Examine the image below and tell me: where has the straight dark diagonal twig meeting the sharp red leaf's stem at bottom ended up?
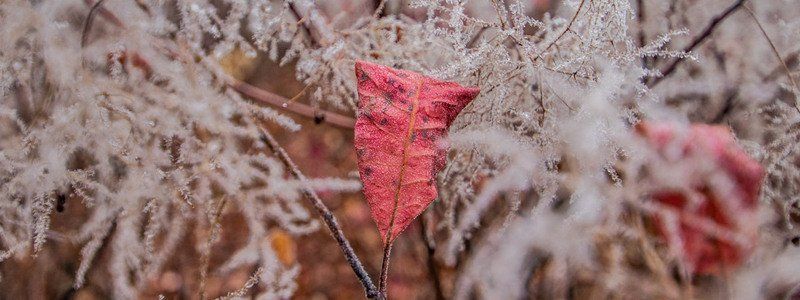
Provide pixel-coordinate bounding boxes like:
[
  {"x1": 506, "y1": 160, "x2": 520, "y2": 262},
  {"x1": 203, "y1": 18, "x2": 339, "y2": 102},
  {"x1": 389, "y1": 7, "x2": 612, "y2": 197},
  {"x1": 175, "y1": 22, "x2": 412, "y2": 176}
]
[{"x1": 261, "y1": 129, "x2": 380, "y2": 299}]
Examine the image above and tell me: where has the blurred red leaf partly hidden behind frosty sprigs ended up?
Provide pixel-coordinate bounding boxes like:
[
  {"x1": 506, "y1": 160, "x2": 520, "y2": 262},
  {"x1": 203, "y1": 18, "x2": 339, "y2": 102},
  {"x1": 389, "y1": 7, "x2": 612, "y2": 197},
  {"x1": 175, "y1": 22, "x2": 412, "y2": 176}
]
[{"x1": 637, "y1": 122, "x2": 764, "y2": 274}]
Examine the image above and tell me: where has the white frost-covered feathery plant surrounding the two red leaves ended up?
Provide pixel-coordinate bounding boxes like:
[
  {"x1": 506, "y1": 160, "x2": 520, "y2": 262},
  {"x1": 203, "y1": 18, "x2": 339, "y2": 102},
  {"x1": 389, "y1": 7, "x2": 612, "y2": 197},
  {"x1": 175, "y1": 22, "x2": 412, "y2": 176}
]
[{"x1": 0, "y1": 0, "x2": 800, "y2": 299}]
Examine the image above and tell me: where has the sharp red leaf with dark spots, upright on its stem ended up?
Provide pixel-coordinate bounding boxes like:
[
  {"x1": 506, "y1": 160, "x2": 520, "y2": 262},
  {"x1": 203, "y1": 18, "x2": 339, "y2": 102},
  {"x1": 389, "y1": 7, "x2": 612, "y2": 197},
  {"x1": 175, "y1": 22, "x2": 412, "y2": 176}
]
[{"x1": 355, "y1": 61, "x2": 480, "y2": 243}]
